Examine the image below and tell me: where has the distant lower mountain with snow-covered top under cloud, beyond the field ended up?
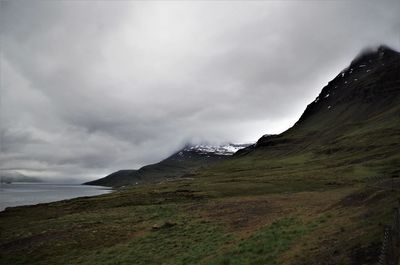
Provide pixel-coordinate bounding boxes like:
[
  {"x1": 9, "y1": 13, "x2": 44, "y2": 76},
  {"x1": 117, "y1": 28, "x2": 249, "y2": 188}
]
[{"x1": 84, "y1": 144, "x2": 249, "y2": 187}]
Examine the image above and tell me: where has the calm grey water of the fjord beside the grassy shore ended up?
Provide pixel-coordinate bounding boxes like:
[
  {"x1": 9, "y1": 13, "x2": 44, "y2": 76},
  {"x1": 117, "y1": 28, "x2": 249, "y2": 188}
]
[{"x1": 0, "y1": 183, "x2": 111, "y2": 211}]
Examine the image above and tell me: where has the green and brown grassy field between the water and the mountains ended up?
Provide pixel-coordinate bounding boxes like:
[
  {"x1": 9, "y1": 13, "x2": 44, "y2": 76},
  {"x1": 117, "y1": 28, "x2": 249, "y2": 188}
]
[{"x1": 0, "y1": 156, "x2": 400, "y2": 265}]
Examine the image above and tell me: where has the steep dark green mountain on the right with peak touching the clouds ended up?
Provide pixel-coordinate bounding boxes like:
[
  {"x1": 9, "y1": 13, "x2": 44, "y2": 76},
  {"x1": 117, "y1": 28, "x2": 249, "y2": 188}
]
[{"x1": 217, "y1": 46, "x2": 400, "y2": 184}]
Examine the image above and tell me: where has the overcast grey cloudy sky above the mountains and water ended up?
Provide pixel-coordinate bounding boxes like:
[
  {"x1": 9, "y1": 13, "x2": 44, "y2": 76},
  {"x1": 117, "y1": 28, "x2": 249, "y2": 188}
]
[{"x1": 0, "y1": 0, "x2": 400, "y2": 181}]
